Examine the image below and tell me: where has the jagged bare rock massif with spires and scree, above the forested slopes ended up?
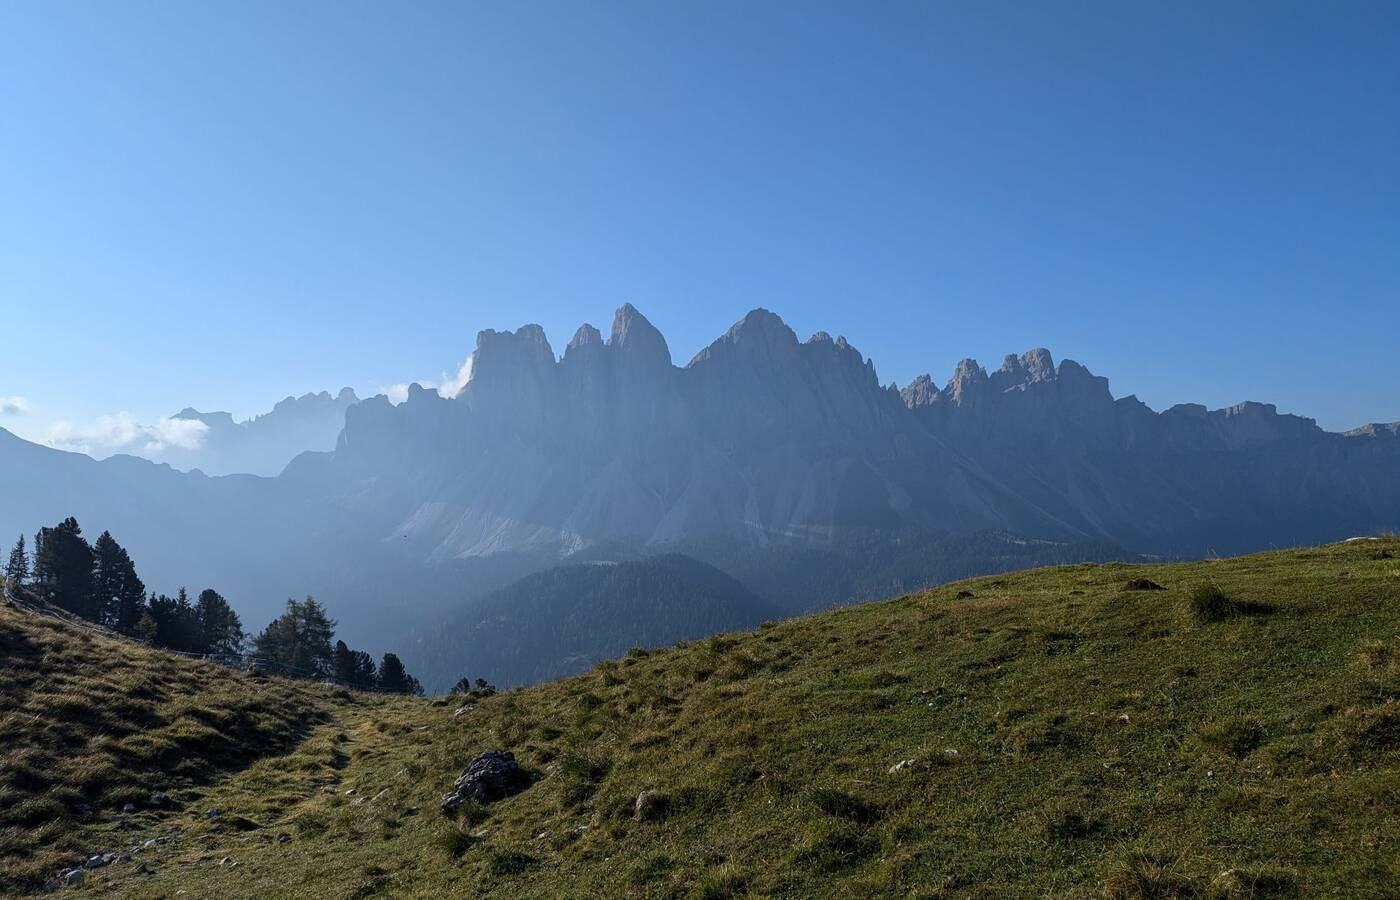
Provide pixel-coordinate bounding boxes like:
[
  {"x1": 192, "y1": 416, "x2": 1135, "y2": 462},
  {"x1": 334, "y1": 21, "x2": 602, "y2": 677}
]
[{"x1": 317, "y1": 305, "x2": 1400, "y2": 560}]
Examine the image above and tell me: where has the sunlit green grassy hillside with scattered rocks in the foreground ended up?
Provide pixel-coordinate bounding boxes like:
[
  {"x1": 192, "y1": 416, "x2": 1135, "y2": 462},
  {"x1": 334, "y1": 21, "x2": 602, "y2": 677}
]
[{"x1": 0, "y1": 540, "x2": 1400, "y2": 899}]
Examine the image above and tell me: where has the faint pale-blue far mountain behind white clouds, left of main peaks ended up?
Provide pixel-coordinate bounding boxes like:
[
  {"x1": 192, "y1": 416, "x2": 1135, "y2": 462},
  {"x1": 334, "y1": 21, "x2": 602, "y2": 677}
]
[{"x1": 141, "y1": 388, "x2": 360, "y2": 476}]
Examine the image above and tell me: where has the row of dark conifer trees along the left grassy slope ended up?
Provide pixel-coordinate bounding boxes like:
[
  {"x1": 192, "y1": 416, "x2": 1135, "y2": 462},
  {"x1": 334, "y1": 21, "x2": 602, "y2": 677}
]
[{"x1": 4, "y1": 516, "x2": 423, "y2": 694}]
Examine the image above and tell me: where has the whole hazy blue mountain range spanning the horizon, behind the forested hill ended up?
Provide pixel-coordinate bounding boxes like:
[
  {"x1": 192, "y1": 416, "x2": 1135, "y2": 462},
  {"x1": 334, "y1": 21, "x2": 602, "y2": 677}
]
[{"x1": 0, "y1": 305, "x2": 1400, "y2": 676}]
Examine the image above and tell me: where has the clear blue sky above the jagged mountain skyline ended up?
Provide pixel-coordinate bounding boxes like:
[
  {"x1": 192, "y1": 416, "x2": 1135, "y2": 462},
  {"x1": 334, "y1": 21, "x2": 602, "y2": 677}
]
[{"x1": 0, "y1": 0, "x2": 1400, "y2": 450}]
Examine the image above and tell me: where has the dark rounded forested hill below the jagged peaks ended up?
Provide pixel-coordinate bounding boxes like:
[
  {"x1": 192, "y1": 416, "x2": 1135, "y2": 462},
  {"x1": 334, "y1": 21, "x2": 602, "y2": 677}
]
[{"x1": 403, "y1": 553, "x2": 778, "y2": 690}]
